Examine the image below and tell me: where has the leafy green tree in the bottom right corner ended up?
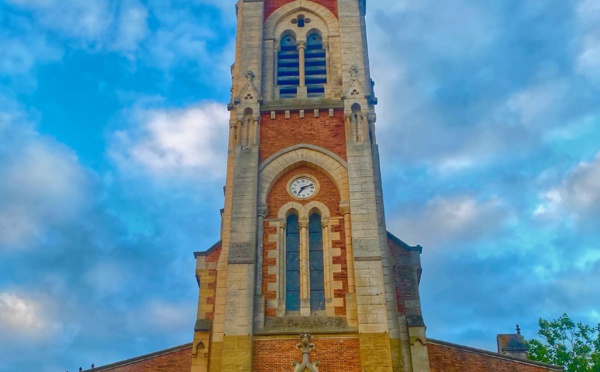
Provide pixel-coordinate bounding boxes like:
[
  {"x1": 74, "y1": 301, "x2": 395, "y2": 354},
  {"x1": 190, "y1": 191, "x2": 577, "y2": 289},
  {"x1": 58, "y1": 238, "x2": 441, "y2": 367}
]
[{"x1": 525, "y1": 314, "x2": 600, "y2": 372}]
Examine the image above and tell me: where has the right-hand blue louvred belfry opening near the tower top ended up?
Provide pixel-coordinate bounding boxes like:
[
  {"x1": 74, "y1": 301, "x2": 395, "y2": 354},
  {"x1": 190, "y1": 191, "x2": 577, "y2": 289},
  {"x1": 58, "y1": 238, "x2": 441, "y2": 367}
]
[{"x1": 304, "y1": 33, "x2": 327, "y2": 97}]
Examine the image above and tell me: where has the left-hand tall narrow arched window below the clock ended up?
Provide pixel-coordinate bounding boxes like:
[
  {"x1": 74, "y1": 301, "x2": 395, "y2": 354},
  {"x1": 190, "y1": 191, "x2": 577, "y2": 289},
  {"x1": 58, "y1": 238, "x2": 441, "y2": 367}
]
[{"x1": 285, "y1": 214, "x2": 300, "y2": 311}]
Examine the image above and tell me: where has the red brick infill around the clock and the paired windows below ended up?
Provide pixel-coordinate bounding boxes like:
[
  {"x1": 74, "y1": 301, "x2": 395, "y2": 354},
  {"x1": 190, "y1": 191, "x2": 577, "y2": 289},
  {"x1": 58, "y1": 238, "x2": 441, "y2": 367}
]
[{"x1": 263, "y1": 166, "x2": 348, "y2": 317}]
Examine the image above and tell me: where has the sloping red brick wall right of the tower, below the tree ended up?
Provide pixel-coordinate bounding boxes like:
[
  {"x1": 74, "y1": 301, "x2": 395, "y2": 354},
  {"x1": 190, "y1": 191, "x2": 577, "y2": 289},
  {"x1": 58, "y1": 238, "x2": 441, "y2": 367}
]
[{"x1": 427, "y1": 342, "x2": 549, "y2": 372}]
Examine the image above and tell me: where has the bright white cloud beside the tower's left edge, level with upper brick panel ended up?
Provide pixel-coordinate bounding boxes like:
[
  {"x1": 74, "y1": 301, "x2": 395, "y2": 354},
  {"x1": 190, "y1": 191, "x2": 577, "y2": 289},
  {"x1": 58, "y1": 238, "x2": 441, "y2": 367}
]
[{"x1": 111, "y1": 103, "x2": 229, "y2": 178}]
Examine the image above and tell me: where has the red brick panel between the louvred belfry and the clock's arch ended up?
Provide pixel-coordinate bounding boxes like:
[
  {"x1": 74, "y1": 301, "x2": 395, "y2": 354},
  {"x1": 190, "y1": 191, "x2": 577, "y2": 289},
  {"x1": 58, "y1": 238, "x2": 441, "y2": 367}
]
[{"x1": 260, "y1": 110, "x2": 346, "y2": 162}]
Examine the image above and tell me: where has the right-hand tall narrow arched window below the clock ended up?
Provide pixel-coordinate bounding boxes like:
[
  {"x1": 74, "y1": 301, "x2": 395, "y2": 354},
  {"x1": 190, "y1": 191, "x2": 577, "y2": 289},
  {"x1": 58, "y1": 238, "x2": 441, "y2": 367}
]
[{"x1": 308, "y1": 214, "x2": 325, "y2": 310}]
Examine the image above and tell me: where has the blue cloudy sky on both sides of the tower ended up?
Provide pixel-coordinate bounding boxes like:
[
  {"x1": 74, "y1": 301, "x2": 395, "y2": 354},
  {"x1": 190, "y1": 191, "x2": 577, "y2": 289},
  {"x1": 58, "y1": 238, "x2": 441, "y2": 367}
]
[{"x1": 0, "y1": 0, "x2": 600, "y2": 372}]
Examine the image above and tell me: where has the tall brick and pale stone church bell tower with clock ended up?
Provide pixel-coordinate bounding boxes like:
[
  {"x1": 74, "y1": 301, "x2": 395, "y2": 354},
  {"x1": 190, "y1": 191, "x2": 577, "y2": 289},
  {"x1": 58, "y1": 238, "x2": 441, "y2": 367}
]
[{"x1": 192, "y1": 0, "x2": 429, "y2": 372}]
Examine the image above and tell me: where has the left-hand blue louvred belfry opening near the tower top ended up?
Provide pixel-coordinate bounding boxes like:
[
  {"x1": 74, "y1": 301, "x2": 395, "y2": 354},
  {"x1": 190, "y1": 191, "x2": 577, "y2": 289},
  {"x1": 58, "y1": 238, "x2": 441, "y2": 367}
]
[{"x1": 277, "y1": 35, "x2": 300, "y2": 98}]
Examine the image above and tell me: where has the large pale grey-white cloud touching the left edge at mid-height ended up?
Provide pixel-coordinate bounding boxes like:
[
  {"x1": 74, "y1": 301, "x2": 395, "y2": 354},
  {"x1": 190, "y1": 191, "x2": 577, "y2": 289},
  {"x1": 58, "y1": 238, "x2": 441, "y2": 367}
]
[{"x1": 0, "y1": 104, "x2": 89, "y2": 250}]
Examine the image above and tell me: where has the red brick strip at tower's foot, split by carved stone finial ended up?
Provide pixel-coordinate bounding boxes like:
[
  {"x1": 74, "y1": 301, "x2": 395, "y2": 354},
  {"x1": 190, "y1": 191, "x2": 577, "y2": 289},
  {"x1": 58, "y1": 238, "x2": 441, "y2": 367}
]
[{"x1": 252, "y1": 338, "x2": 360, "y2": 372}]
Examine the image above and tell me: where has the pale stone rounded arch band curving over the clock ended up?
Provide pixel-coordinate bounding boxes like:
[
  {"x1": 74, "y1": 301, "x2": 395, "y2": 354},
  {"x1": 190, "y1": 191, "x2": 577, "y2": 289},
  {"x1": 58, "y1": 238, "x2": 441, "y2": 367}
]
[{"x1": 258, "y1": 145, "x2": 349, "y2": 204}]
